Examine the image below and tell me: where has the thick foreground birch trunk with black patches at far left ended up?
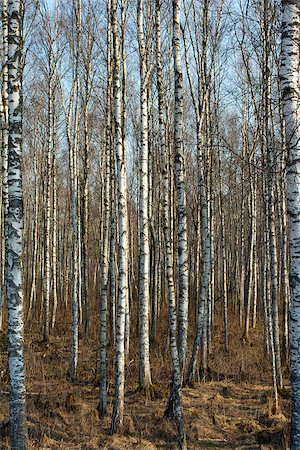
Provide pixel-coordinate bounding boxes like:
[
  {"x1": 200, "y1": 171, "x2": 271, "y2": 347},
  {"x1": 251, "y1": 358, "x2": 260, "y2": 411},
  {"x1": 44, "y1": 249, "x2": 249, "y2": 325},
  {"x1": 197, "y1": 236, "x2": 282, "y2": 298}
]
[{"x1": 7, "y1": 0, "x2": 28, "y2": 450}]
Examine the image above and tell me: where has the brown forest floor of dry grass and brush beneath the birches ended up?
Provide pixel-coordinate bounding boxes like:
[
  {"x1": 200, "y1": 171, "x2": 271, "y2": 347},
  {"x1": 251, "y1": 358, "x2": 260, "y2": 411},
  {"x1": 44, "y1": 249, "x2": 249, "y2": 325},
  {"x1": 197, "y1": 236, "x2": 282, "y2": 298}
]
[{"x1": 0, "y1": 318, "x2": 290, "y2": 450}]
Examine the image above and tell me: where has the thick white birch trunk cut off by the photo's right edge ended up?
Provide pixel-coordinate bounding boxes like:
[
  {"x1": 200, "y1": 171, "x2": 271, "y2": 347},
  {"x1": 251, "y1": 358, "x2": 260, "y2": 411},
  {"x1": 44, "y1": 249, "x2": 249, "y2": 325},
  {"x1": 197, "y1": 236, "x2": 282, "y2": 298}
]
[{"x1": 280, "y1": 0, "x2": 300, "y2": 450}]
